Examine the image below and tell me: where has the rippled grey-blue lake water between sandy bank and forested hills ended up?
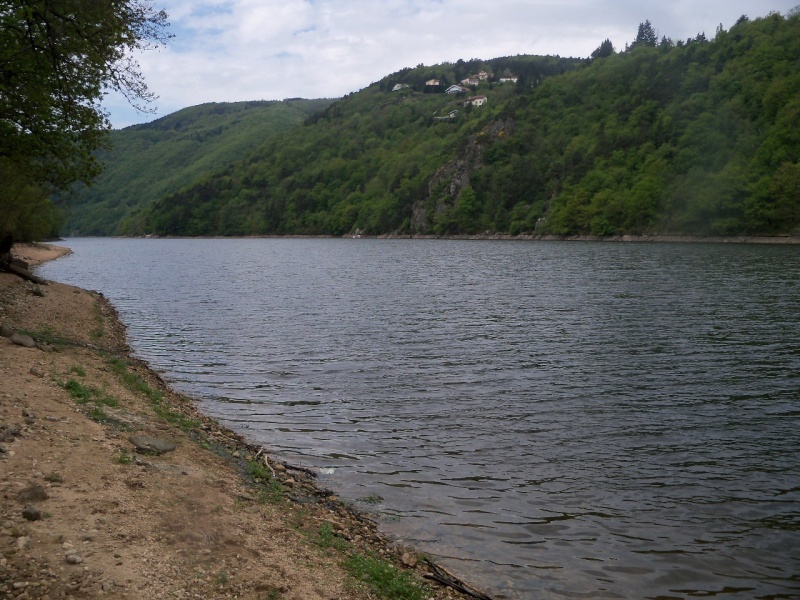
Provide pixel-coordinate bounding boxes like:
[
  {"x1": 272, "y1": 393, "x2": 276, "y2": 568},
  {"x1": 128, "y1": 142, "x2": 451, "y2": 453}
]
[{"x1": 38, "y1": 239, "x2": 800, "y2": 599}]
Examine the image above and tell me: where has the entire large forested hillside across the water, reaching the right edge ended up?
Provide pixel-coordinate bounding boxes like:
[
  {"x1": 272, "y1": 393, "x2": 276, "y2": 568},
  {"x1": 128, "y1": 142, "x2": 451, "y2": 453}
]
[{"x1": 109, "y1": 14, "x2": 800, "y2": 235}]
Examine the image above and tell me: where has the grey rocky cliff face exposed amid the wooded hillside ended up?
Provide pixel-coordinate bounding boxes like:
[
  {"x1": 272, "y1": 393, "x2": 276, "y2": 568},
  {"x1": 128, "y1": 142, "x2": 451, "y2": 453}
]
[{"x1": 411, "y1": 119, "x2": 514, "y2": 231}]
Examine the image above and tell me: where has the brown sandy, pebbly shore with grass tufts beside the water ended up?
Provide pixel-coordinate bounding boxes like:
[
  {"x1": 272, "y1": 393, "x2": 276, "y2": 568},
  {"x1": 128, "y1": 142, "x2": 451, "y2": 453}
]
[{"x1": 0, "y1": 245, "x2": 482, "y2": 600}]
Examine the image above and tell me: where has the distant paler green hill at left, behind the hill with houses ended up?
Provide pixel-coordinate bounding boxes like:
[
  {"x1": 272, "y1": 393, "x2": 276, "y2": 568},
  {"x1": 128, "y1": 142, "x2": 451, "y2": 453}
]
[{"x1": 58, "y1": 99, "x2": 331, "y2": 235}]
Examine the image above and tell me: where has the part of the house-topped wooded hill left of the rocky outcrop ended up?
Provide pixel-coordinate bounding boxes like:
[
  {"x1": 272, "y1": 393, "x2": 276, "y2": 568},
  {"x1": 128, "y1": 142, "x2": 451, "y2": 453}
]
[{"x1": 122, "y1": 56, "x2": 582, "y2": 235}]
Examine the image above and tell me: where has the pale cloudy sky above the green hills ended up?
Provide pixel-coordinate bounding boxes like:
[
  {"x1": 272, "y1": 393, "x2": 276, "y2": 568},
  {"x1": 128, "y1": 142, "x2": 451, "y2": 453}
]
[{"x1": 105, "y1": 0, "x2": 800, "y2": 128}]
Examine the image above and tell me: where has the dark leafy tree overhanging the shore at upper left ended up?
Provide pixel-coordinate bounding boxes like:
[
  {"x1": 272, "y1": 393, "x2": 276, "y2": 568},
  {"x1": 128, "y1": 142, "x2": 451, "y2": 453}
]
[{"x1": 0, "y1": 0, "x2": 168, "y2": 244}]
